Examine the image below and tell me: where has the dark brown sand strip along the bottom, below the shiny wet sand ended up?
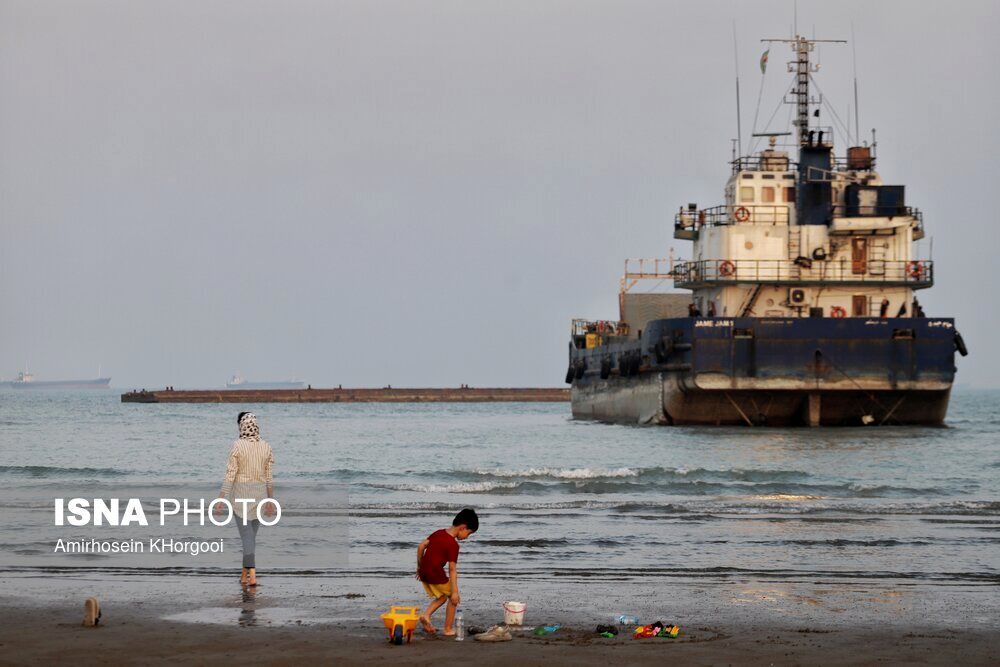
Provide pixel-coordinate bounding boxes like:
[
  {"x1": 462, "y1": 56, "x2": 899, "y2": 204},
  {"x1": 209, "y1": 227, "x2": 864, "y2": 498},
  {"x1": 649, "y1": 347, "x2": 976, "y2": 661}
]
[{"x1": 0, "y1": 600, "x2": 1000, "y2": 665}]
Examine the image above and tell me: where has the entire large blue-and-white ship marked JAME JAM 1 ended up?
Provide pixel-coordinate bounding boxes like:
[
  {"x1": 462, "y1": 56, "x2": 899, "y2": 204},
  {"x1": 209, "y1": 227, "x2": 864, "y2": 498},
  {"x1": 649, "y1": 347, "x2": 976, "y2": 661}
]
[{"x1": 566, "y1": 36, "x2": 968, "y2": 426}]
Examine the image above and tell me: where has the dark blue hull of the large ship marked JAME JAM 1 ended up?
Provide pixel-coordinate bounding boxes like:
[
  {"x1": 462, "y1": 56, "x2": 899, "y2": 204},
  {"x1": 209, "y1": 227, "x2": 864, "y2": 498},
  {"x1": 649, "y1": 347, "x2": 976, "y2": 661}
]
[{"x1": 567, "y1": 318, "x2": 957, "y2": 425}]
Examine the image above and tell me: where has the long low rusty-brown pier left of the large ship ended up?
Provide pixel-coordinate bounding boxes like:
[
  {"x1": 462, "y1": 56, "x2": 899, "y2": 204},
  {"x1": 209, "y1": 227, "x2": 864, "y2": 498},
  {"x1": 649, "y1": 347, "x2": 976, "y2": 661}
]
[{"x1": 122, "y1": 387, "x2": 569, "y2": 403}]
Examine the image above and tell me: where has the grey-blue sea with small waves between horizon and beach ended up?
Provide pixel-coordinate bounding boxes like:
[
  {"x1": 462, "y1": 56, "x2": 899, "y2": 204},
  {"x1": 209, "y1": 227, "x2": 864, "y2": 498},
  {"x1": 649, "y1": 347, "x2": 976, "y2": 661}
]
[{"x1": 0, "y1": 390, "x2": 1000, "y2": 623}]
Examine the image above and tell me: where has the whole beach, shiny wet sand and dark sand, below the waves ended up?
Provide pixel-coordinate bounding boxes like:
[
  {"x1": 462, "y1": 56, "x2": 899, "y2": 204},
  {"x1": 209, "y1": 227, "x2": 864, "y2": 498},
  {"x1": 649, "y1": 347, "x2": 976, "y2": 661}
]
[{"x1": 0, "y1": 575, "x2": 1000, "y2": 665}]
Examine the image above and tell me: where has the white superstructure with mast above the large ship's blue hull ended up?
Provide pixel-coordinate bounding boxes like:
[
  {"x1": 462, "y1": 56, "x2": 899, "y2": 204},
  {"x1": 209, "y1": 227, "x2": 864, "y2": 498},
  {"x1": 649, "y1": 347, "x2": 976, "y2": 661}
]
[{"x1": 673, "y1": 37, "x2": 933, "y2": 317}]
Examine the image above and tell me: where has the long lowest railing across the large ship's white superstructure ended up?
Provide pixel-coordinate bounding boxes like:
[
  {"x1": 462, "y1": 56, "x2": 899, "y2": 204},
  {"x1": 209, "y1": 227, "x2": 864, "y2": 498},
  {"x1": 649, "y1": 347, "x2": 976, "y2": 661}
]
[{"x1": 674, "y1": 258, "x2": 934, "y2": 288}]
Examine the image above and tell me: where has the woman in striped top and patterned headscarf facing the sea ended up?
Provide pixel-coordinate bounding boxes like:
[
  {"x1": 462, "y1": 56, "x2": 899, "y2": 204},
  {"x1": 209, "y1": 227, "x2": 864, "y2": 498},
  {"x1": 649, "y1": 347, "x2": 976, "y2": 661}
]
[{"x1": 215, "y1": 412, "x2": 274, "y2": 586}]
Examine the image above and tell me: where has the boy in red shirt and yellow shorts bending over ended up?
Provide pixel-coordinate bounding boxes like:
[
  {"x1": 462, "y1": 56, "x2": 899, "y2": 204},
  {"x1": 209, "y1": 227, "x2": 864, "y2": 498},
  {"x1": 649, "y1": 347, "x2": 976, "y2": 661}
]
[{"x1": 417, "y1": 508, "x2": 479, "y2": 637}]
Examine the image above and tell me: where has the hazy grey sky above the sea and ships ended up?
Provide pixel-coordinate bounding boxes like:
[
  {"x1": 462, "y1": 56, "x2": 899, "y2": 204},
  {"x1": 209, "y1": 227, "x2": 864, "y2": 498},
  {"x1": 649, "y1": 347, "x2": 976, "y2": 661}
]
[{"x1": 0, "y1": 0, "x2": 1000, "y2": 389}]
